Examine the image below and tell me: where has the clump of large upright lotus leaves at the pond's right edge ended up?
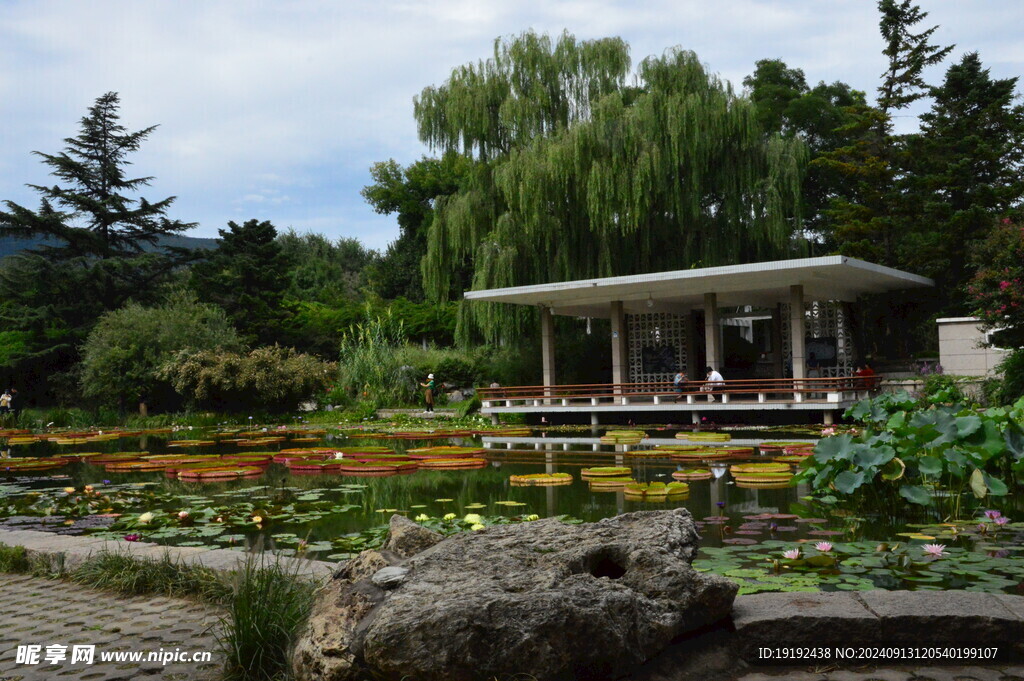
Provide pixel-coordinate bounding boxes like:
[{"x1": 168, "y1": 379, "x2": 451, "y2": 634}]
[{"x1": 800, "y1": 389, "x2": 1024, "y2": 518}]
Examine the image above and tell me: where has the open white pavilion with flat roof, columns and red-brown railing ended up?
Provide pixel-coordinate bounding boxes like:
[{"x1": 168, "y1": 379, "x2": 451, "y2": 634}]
[{"x1": 465, "y1": 255, "x2": 934, "y2": 423}]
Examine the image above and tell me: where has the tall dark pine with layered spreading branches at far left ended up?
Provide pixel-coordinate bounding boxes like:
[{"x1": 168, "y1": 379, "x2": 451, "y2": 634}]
[{"x1": 0, "y1": 92, "x2": 194, "y2": 391}]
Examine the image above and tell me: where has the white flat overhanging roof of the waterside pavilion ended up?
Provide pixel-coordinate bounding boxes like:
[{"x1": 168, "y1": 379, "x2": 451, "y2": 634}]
[{"x1": 464, "y1": 255, "x2": 934, "y2": 317}]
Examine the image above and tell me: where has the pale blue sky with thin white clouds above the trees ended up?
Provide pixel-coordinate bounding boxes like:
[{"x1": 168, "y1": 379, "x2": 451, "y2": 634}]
[{"x1": 0, "y1": 0, "x2": 1024, "y2": 249}]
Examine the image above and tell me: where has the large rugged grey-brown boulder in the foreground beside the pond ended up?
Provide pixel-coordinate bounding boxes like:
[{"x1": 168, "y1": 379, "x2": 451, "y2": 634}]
[{"x1": 293, "y1": 509, "x2": 736, "y2": 681}]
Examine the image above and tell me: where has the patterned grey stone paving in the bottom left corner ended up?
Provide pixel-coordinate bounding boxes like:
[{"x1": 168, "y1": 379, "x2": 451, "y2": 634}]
[{"x1": 0, "y1": 573, "x2": 223, "y2": 681}]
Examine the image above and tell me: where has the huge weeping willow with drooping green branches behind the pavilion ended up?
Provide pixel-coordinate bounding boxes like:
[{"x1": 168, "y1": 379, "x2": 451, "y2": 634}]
[{"x1": 415, "y1": 33, "x2": 806, "y2": 339}]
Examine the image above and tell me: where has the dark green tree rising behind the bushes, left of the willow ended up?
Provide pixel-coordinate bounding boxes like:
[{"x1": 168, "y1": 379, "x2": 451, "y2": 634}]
[{"x1": 190, "y1": 220, "x2": 292, "y2": 344}]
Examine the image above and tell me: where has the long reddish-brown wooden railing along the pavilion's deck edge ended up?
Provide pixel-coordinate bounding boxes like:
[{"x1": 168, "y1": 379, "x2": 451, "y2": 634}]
[{"x1": 476, "y1": 377, "x2": 877, "y2": 409}]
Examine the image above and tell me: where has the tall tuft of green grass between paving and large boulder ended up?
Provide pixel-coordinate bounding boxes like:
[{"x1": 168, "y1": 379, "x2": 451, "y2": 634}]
[{"x1": 218, "y1": 553, "x2": 316, "y2": 681}]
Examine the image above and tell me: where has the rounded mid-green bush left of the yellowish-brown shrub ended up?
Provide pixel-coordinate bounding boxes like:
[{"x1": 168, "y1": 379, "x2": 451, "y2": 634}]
[{"x1": 81, "y1": 293, "x2": 242, "y2": 410}]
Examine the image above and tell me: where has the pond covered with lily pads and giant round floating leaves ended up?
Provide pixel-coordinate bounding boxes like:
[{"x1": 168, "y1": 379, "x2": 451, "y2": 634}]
[{"x1": 0, "y1": 427, "x2": 1024, "y2": 593}]
